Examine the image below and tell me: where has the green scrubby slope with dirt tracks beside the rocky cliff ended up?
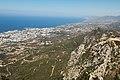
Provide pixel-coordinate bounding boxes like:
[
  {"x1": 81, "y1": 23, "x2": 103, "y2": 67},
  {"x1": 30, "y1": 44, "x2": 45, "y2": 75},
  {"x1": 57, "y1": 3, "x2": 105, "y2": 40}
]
[{"x1": 1, "y1": 32, "x2": 84, "y2": 80}]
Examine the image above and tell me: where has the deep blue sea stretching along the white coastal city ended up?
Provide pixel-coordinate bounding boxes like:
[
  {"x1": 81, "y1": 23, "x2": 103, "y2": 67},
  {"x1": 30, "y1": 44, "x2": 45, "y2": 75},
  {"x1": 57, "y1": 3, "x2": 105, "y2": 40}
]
[{"x1": 0, "y1": 16, "x2": 85, "y2": 32}]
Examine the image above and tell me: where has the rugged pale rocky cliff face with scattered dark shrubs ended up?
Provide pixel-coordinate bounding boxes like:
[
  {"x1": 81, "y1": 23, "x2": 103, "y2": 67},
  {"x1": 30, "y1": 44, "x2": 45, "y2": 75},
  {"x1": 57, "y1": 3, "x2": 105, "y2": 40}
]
[{"x1": 63, "y1": 30, "x2": 120, "y2": 80}]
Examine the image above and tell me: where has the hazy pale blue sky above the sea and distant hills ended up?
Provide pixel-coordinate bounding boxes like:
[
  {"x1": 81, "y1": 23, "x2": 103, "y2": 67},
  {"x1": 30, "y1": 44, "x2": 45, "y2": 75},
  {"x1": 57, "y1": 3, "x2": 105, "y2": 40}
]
[{"x1": 0, "y1": 0, "x2": 120, "y2": 17}]
